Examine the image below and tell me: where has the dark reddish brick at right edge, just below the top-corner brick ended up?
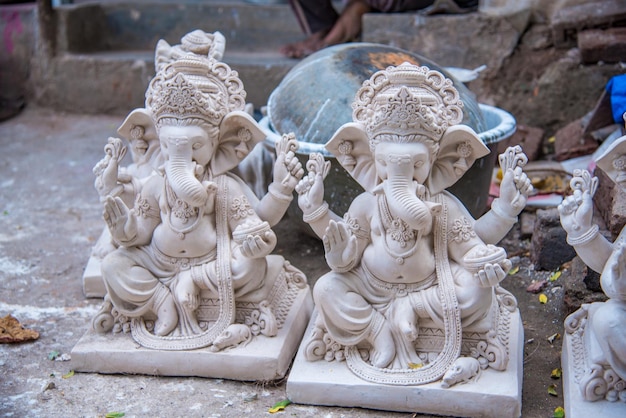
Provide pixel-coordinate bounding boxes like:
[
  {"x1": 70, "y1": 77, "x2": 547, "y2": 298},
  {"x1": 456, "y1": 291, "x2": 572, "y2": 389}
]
[{"x1": 578, "y1": 27, "x2": 626, "y2": 64}]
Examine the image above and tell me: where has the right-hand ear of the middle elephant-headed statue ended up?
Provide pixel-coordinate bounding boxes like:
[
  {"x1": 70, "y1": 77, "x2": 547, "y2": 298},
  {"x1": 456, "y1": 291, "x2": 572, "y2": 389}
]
[{"x1": 427, "y1": 125, "x2": 490, "y2": 195}]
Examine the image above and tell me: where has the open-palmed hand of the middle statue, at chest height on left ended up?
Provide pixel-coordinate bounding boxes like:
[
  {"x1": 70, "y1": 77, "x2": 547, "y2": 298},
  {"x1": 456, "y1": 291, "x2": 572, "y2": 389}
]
[{"x1": 322, "y1": 220, "x2": 357, "y2": 272}]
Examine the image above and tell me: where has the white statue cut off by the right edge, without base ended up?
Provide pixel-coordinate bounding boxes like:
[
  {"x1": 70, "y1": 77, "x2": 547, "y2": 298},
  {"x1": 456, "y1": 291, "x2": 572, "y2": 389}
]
[{"x1": 559, "y1": 128, "x2": 626, "y2": 404}]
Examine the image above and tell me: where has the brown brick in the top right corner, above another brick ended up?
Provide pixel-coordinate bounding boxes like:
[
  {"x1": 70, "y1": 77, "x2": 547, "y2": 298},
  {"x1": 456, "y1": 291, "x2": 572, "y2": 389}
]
[{"x1": 551, "y1": 0, "x2": 626, "y2": 48}]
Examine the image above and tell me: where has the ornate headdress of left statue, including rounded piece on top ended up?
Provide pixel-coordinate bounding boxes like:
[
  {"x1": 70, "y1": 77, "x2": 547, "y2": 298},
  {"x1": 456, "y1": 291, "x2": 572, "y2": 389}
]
[{"x1": 146, "y1": 31, "x2": 246, "y2": 126}]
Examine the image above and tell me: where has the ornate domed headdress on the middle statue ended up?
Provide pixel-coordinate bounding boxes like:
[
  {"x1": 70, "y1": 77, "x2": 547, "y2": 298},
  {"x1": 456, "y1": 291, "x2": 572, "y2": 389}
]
[{"x1": 352, "y1": 62, "x2": 463, "y2": 147}]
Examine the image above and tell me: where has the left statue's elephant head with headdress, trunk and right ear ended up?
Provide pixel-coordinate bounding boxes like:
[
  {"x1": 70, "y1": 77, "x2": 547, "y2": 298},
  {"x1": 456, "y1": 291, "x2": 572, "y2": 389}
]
[{"x1": 146, "y1": 31, "x2": 265, "y2": 207}]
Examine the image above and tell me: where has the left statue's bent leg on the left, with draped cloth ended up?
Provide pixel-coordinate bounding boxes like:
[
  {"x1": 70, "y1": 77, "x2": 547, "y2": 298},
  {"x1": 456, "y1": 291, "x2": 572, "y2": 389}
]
[{"x1": 102, "y1": 250, "x2": 178, "y2": 335}]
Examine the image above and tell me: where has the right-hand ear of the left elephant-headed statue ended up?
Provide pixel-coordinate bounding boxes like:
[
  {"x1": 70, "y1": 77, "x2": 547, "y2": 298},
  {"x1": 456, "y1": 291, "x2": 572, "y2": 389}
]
[{"x1": 211, "y1": 110, "x2": 266, "y2": 176}]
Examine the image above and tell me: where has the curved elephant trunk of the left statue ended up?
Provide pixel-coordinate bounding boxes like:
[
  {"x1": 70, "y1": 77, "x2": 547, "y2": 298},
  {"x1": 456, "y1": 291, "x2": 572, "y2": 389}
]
[{"x1": 165, "y1": 138, "x2": 208, "y2": 207}]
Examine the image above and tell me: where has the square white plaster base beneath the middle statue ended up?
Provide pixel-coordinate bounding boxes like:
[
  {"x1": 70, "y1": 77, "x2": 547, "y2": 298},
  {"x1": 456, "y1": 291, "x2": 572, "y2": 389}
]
[{"x1": 287, "y1": 312, "x2": 524, "y2": 418}]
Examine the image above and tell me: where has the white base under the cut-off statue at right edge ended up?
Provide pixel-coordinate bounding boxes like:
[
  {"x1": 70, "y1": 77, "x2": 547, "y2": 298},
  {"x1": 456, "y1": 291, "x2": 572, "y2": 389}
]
[{"x1": 561, "y1": 332, "x2": 626, "y2": 418}]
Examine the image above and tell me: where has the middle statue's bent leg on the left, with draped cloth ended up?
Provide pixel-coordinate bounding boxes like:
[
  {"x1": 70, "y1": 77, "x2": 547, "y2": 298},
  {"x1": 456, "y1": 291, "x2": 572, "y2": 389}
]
[{"x1": 313, "y1": 272, "x2": 396, "y2": 367}]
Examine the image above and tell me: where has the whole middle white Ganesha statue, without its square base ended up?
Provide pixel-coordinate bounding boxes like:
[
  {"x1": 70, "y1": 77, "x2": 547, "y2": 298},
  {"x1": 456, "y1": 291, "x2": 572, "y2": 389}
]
[{"x1": 296, "y1": 63, "x2": 532, "y2": 387}]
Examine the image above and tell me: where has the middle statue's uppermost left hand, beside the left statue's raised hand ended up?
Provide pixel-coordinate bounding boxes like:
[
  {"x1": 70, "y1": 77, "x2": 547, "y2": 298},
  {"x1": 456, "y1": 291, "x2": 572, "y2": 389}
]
[{"x1": 296, "y1": 153, "x2": 330, "y2": 215}]
